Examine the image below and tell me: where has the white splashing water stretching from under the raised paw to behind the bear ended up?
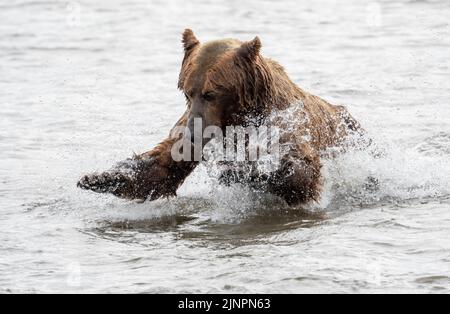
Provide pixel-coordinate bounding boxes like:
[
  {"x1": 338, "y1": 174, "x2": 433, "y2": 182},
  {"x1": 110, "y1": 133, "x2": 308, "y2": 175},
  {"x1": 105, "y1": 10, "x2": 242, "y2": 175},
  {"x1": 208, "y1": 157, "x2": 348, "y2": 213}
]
[{"x1": 91, "y1": 112, "x2": 450, "y2": 223}]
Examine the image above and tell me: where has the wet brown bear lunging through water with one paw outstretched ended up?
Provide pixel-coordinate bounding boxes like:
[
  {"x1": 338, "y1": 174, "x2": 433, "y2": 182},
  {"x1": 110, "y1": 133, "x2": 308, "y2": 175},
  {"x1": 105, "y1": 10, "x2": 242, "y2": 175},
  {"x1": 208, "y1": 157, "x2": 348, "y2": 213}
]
[{"x1": 78, "y1": 29, "x2": 361, "y2": 205}]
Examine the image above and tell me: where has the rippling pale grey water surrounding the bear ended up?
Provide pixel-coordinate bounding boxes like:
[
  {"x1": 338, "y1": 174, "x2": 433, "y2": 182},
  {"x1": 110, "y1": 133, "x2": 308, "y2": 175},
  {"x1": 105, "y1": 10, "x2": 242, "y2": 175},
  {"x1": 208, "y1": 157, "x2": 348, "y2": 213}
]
[{"x1": 0, "y1": 0, "x2": 450, "y2": 293}]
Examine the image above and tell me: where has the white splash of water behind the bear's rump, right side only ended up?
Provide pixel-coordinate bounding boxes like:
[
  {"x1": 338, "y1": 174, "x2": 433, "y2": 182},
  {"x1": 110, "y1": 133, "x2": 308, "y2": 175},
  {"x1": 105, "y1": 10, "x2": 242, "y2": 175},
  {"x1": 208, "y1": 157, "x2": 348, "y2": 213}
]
[{"x1": 322, "y1": 131, "x2": 450, "y2": 211}]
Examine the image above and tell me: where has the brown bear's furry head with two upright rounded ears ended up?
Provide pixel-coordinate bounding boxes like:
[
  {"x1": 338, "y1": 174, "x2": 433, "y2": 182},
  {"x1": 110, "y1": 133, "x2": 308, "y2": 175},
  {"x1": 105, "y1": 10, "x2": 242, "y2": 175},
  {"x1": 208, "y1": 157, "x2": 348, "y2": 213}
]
[{"x1": 178, "y1": 29, "x2": 283, "y2": 142}]
